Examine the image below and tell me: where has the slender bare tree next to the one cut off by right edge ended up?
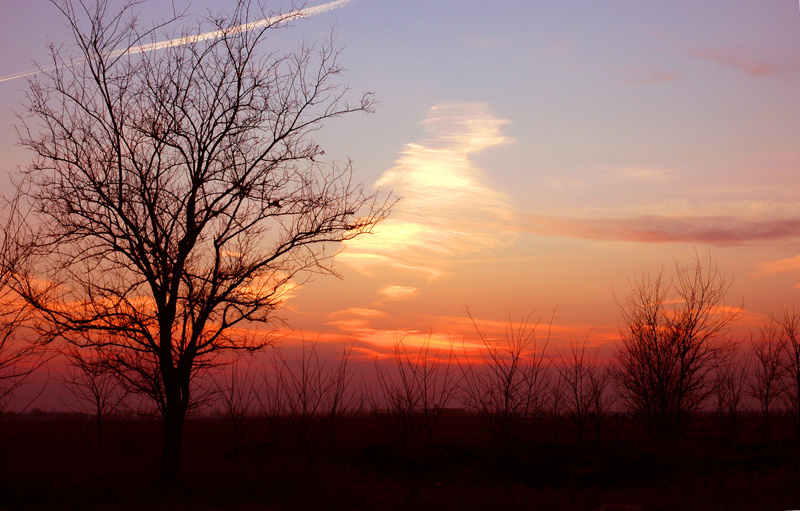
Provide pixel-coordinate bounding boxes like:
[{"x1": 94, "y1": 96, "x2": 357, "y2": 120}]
[{"x1": 748, "y1": 326, "x2": 785, "y2": 443}]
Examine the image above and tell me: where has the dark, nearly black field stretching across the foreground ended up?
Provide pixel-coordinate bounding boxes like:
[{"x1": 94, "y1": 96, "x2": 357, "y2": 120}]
[{"x1": 0, "y1": 416, "x2": 800, "y2": 510}]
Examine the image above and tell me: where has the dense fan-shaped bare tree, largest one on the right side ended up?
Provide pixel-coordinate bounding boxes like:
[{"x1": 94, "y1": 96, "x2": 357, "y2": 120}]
[{"x1": 613, "y1": 256, "x2": 741, "y2": 437}]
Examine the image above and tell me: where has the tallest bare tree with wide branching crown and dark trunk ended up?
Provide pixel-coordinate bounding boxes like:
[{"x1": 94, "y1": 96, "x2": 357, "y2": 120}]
[{"x1": 11, "y1": 0, "x2": 389, "y2": 484}]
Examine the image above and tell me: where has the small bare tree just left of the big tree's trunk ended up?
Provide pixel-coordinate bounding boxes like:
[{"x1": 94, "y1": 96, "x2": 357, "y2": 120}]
[{"x1": 61, "y1": 345, "x2": 127, "y2": 449}]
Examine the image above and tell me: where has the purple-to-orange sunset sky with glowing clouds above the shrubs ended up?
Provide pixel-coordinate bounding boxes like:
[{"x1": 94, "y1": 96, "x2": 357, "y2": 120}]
[{"x1": 0, "y1": 0, "x2": 800, "y2": 376}]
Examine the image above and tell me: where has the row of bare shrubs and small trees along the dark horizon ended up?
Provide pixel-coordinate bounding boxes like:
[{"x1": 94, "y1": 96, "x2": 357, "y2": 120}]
[{"x1": 29, "y1": 294, "x2": 800, "y2": 458}]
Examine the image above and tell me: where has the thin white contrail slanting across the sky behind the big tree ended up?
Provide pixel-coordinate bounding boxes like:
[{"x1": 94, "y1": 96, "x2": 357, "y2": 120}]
[{"x1": 0, "y1": 0, "x2": 356, "y2": 83}]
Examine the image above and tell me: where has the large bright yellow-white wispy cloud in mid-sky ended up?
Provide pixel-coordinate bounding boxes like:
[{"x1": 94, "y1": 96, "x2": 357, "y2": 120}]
[{"x1": 339, "y1": 103, "x2": 516, "y2": 277}]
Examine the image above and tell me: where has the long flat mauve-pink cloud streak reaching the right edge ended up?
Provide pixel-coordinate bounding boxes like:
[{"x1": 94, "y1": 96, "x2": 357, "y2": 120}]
[{"x1": 525, "y1": 215, "x2": 800, "y2": 245}]
